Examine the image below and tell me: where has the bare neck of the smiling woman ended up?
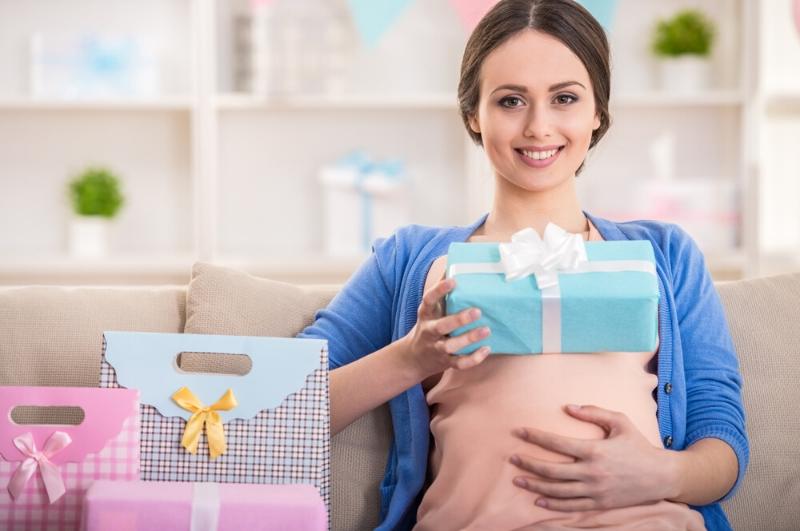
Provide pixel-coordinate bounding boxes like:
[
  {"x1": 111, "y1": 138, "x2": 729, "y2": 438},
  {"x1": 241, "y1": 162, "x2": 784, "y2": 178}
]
[{"x1": 482, "y1": 172, "x2": 589, "y2": 235}]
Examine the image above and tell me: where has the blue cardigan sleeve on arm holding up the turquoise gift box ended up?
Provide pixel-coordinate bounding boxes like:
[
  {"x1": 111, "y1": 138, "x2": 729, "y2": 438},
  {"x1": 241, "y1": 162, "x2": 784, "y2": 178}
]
[{"x1": 297, "y1": 235, "x2": 397, "y2": 370}]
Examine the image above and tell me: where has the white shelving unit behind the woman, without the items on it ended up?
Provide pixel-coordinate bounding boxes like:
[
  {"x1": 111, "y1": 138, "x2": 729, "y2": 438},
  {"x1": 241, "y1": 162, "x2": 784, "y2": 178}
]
[{"x1": 0, "y1": 0, "x2": 800, "y2": 284}]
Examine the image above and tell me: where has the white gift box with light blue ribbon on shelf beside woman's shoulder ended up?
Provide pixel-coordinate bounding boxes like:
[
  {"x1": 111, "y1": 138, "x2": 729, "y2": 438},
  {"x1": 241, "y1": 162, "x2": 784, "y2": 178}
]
[{"x1": 319, "y1": 151, "x2": 410, "y2": 257}]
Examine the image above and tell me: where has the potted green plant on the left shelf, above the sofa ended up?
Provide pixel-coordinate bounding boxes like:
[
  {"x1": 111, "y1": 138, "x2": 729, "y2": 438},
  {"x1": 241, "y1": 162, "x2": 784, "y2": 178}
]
[{"x1": 68, "y1": 167, "x2": 125, "y2": 258}]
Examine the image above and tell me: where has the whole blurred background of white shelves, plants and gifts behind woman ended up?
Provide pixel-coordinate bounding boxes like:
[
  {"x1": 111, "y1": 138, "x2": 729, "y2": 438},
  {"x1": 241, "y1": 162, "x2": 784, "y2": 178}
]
[{"x1": 0, "y1": 0, "x2": 800, "y2": 284}]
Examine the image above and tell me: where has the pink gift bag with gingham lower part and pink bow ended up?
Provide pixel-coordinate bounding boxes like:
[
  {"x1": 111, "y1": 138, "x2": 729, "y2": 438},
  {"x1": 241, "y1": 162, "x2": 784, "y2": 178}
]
[{"x1": 0, "y1": 387, "x2": 139, "y2": 531}]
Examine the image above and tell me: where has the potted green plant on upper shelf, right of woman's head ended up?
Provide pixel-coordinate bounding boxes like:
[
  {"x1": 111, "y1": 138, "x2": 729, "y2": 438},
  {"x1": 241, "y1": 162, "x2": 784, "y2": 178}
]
[{"x1": 651, "y1": 9, "x2": 716, "y2": 93}]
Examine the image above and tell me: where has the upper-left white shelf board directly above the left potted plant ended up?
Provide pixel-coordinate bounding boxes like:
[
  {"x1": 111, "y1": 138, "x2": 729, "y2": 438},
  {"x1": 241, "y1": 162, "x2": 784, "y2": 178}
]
[{"x1": 0, "y1": 97, "x2": 192, "y2": 111}]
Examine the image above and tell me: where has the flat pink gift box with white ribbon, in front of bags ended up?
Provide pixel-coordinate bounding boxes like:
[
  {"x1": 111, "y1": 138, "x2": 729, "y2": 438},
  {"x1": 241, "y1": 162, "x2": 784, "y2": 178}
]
[{"x1": 83, "y1": 481, "x2": 328, "y2": 531}]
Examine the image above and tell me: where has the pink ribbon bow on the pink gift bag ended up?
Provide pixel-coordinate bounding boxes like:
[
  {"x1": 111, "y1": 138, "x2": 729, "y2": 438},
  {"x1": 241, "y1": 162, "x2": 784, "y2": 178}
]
[{"x1": 8, "y1": 431, "x2": 72, "y2": 503}]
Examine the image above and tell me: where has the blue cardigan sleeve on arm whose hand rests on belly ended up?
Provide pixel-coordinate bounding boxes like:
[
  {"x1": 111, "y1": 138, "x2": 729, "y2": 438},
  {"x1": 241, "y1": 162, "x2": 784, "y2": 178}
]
[{"x1": 671, "y1": 227, "x2": 749, "y2": 500}]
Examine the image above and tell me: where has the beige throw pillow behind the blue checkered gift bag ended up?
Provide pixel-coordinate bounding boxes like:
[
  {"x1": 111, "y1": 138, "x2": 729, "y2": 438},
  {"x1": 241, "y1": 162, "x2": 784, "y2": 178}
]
[{"x1": 181, "y1": 263, "x2": 392, "y2": 530}]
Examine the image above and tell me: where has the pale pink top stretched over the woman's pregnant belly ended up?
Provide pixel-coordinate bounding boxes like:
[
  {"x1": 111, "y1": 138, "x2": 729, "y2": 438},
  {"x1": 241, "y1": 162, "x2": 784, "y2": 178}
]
[{"x1": 415, "y1": 223, "x2": 705, "y2": 531}]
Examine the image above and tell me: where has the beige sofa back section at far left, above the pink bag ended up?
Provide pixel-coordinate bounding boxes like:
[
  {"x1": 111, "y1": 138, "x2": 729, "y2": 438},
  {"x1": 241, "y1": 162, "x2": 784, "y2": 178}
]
[{"x1": 0, "y1": 286, "x2": 186, "y2": 387}]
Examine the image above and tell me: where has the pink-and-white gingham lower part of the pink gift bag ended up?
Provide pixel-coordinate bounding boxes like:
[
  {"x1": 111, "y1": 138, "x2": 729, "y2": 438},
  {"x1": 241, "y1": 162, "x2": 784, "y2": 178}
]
[{"x1": 0, "y1": 415, "x2": 139, "y2": 531}]
